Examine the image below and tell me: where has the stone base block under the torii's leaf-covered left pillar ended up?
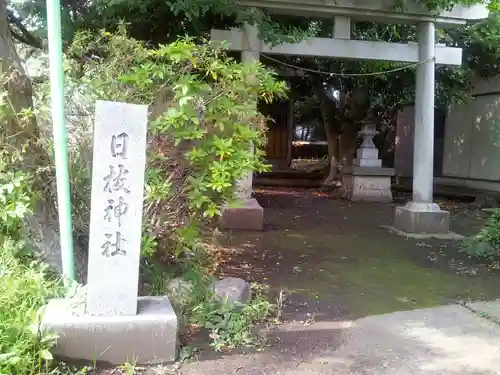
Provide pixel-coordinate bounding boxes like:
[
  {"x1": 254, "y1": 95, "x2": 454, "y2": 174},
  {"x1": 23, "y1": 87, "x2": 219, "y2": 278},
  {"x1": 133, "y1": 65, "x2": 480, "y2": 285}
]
[{"x1": 220, "y1": 198, "x2": 264, "y2": 230}]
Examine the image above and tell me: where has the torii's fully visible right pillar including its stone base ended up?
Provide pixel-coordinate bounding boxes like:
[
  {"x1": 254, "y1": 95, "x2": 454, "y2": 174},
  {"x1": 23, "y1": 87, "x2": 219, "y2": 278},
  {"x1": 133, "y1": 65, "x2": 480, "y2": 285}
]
[{"x1": 395, "y1": 22, "x2": 450, "y2": 234}]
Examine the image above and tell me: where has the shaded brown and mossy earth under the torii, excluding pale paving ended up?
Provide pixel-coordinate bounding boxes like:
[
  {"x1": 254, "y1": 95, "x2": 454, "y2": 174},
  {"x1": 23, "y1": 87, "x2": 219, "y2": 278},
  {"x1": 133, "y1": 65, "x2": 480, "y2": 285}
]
[{"x1": 216, "y1": 189, "x2": 500, "y2": 321}]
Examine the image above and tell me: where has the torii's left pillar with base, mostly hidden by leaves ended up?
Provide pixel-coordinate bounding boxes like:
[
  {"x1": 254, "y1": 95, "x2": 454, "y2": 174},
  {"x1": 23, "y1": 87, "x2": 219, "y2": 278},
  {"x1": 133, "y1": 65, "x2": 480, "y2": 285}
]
[{"x1": 221, "y1": 24, "x2": 264, "y2": 230}]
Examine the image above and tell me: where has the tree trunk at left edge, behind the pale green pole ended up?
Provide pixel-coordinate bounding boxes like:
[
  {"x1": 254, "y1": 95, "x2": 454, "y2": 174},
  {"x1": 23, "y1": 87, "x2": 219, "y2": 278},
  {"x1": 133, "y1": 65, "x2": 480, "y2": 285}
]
[{"x1": 0, "y1": 0, "x2": 86, "y2": 281}]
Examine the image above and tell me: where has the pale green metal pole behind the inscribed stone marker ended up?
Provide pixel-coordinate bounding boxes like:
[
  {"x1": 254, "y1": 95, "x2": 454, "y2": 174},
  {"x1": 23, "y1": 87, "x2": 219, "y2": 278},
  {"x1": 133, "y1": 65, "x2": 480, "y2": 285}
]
[{"x1": 47, "y1": 0, "x2": 75, "y2": 281}]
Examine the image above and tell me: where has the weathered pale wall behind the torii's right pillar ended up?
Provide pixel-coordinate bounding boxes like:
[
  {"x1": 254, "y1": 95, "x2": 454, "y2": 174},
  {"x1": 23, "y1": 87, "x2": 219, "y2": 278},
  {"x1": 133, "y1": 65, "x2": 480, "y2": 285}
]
[{"x1": 394, "y1": 76, "x2": 500, "y2": 191}]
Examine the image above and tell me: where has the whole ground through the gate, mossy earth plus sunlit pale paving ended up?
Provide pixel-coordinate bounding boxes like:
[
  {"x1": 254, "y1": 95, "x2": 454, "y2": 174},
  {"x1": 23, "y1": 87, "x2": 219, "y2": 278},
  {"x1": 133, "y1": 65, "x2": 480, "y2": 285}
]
[{"x1": 174, "y1": 189, "x2": 500, "y2": 375}]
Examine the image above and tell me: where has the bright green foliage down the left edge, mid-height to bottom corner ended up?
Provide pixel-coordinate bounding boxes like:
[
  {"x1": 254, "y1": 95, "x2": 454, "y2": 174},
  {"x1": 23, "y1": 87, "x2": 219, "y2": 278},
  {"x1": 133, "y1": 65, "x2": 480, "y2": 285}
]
[{"x1": 0, "y1": 78, "x2": 60, "y2": 375}]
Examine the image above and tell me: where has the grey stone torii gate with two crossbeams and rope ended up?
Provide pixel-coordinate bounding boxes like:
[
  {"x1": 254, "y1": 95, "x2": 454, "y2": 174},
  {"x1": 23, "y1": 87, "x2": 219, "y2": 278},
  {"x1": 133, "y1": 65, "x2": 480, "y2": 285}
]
[{"x1": 216, "y1": 0, "x2": 488, "y2": 234}]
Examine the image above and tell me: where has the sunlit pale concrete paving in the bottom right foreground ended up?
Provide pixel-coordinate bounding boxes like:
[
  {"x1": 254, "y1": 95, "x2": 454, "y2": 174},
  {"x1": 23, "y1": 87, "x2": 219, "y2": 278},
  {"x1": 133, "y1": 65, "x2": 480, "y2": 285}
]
[{"x1": 181, "y1": 305, "x2": 500, "y2": 375}]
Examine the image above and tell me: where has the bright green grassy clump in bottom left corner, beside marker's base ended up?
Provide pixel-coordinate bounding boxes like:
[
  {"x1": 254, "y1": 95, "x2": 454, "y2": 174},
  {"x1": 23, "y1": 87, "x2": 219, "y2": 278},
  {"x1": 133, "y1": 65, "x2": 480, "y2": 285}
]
[{"x1": 0, "y1": 240, "x2": 60, "y2": 375}]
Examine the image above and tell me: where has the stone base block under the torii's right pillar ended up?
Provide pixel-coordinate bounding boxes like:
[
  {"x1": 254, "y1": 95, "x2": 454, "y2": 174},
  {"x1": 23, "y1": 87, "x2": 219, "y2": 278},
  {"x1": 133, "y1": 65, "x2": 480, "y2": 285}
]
[{"x1": 394, "y1": 202, "x2": 450, "y2": 234}]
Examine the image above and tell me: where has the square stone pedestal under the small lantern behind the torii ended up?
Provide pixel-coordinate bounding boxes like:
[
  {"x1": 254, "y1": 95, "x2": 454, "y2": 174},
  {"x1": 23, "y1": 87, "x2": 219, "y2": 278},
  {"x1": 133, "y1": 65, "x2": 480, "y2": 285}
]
[{"x1": 341, "y1": 166, "x2": 394, "y2": 203}]
